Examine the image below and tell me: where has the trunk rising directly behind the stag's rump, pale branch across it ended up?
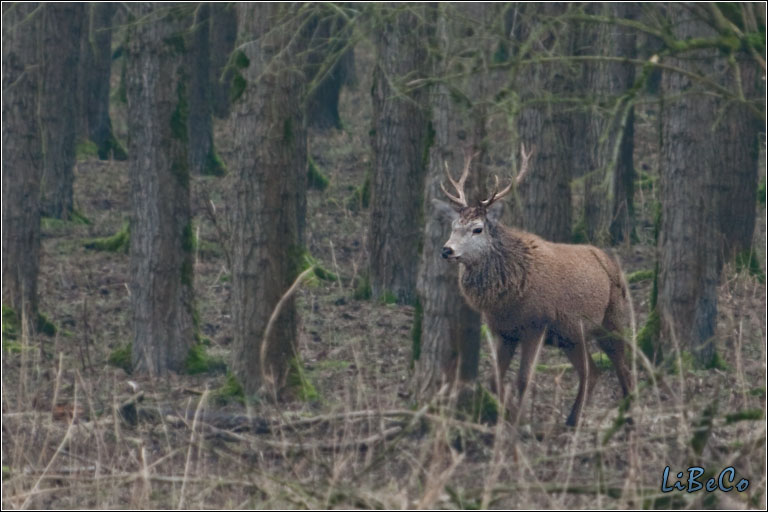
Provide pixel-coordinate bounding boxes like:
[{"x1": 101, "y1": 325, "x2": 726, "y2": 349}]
[{"x1": 574, "y1": 3, "x2": 636, "y2": 244}]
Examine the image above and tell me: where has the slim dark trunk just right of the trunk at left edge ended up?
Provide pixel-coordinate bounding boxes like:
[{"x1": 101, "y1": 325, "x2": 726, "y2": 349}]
[{"x1": 40, "y1": 2, "x2": 85, "y2": 219}]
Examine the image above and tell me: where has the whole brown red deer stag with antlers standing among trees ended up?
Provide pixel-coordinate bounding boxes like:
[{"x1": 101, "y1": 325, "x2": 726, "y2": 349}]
[{"x1": 435, "y1": 147, "x2": 633, "y2": 426}]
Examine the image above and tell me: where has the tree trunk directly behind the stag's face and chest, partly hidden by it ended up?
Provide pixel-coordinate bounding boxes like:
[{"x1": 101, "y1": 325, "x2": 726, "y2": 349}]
[{"x1": 413, "y1": 4, "x2": 492, "y2": 398}]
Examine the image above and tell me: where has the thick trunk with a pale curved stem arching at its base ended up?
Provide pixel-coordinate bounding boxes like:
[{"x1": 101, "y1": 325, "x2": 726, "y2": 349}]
[{"x1": 232, "y1": 4, "x2": 307, "y2": 395}]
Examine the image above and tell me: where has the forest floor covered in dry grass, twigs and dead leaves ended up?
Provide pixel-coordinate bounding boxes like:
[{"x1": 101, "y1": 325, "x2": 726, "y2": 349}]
[{"x1": 2, "y1": 44, "x2": 766, "y2": 509}]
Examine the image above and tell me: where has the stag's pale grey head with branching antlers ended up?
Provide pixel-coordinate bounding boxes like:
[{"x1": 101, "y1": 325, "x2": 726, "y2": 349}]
[{"x1": 435, "y1": 146, "x2": 533, "y2": 264}]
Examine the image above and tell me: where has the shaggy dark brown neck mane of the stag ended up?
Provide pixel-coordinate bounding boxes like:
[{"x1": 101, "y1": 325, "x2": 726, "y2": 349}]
[{"x1": 461, "y1": 222, "x2": 530, "y2": 309}]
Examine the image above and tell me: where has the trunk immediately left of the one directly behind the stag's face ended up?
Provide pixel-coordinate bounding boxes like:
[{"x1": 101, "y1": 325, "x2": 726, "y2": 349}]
[{"x1": 368, "y1": 4, "x2": 434, "y2": 303}]
